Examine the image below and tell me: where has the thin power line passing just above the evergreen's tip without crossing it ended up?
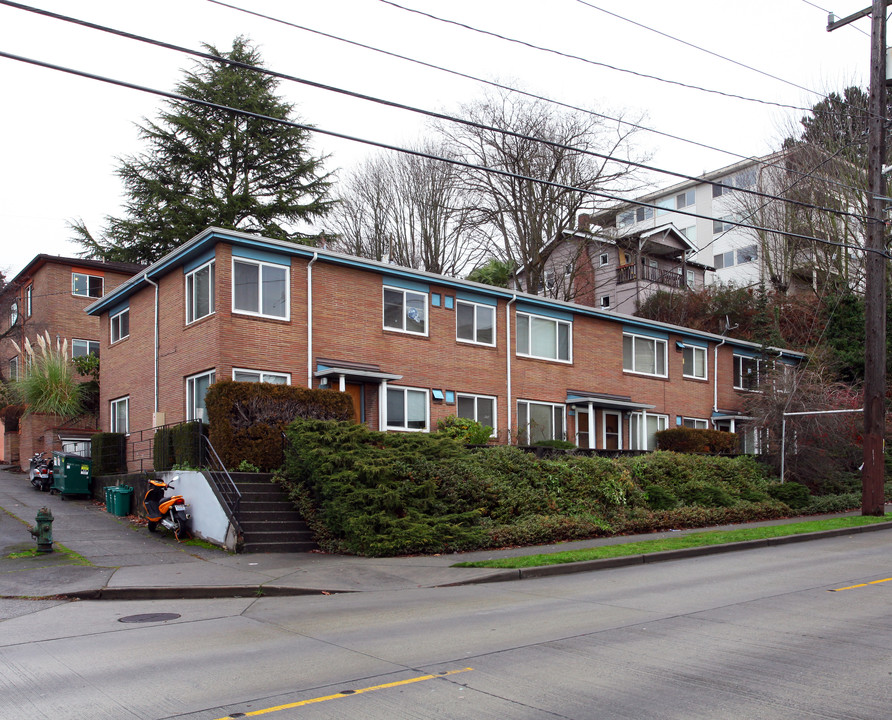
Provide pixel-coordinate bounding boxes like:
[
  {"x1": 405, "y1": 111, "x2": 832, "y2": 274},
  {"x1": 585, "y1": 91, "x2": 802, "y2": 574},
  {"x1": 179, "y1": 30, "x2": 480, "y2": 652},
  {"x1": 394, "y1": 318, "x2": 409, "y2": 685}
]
[{"x1": 204, "y1": 0, "x2": 880, "y2": 202}]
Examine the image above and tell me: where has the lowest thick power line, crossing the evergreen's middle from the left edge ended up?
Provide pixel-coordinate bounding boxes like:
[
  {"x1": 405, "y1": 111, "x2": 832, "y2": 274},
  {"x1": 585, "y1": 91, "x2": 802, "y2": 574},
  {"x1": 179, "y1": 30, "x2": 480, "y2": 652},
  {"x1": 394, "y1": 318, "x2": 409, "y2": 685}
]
[{"x1": 0, "y1": 50, "x2": 892, "y2": 259}]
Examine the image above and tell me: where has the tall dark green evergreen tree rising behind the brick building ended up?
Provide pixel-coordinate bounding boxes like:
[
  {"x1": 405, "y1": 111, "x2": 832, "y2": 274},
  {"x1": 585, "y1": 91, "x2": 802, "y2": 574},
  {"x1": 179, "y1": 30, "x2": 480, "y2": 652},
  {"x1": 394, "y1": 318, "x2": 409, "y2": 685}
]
[{"x1": 71, "y1": 37, "x2": 332, "y2": 262}]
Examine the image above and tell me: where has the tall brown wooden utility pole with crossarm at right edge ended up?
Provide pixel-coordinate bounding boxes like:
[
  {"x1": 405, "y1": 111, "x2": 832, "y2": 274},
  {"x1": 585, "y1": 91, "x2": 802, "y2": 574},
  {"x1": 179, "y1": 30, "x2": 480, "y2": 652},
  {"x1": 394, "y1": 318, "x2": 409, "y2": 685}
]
[{"x1": 827, "y1": 0, "x2": 888, "y2": 515}]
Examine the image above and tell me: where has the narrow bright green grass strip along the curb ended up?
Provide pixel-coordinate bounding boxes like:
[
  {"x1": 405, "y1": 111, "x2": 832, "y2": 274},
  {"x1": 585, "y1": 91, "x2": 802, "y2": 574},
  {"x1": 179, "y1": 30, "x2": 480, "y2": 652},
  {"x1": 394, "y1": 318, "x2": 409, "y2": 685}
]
[{"x1": 452, "y1": 515, "x2": 892, "y2": 568}]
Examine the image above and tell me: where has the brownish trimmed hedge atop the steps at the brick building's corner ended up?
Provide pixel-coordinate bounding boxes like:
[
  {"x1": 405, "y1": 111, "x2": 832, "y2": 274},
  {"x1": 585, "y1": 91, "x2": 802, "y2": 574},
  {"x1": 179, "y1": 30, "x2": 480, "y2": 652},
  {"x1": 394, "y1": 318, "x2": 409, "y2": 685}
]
[{"x1": 205, "y1": 380, "x2": 353, "y2": 471}]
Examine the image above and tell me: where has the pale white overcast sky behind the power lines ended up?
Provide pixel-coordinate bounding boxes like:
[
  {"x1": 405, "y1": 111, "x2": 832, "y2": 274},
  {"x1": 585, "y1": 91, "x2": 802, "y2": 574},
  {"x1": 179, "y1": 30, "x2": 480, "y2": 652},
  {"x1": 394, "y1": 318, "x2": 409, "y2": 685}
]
[{"x1": 0, "y1": 0, "x2": 870, "y2": 275}]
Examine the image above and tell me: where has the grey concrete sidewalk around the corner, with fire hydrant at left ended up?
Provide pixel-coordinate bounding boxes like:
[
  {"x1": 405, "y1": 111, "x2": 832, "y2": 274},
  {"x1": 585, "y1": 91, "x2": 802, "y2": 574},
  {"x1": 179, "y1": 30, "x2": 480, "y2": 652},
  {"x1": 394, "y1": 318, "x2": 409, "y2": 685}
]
[{"x1": 0, "y1": 469, "x2": 892, "y2": 599}]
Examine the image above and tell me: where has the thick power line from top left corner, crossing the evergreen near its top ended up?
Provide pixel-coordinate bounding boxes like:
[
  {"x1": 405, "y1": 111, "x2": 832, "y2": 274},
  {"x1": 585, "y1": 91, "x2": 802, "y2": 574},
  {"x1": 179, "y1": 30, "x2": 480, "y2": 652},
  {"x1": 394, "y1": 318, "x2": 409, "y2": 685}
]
[{"x1": 0, "y1": 0, "x2": 864, "y2": 225}]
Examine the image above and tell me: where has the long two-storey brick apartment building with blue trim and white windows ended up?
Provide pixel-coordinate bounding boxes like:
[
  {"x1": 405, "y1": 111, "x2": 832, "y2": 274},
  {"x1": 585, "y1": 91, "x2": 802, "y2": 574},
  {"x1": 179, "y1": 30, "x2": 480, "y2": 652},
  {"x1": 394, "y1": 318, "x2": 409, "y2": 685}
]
[{"x1": 87, "y1": 228, "x2": 802, "y2": 462}]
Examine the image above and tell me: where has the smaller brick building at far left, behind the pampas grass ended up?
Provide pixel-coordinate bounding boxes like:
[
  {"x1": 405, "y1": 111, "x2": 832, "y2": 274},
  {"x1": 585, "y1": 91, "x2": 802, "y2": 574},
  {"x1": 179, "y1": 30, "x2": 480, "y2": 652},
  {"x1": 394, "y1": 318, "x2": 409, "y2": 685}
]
[{"x1": 0, "y1": 255, "x2": 143, "y2": 467}]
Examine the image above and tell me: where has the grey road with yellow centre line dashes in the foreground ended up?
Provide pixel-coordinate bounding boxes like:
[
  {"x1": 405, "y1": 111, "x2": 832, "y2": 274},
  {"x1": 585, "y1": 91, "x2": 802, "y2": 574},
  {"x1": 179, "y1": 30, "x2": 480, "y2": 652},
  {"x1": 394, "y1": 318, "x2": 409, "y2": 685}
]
[{"x1": 0, "y1": 533, "x2": 892, "y2": 720}]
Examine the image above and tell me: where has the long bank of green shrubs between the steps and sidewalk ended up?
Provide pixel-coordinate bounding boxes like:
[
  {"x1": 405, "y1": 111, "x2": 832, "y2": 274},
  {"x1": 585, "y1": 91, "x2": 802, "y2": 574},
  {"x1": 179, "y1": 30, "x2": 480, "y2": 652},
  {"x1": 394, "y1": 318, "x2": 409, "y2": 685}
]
[{"x1": 279, "y1": 420, "x2": 807, "y2": 555}]
